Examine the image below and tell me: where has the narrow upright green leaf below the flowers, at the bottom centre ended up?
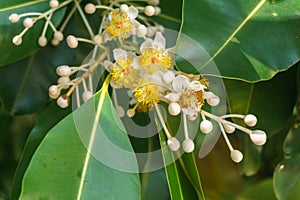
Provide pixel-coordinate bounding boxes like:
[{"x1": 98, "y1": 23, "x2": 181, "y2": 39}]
[{"x1": 157, "y1": 108, "x2": 205, "y2": 200}]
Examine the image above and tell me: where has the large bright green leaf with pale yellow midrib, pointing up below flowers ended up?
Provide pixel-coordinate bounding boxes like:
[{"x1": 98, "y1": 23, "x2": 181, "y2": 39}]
[{"x1": 20, "y1": 79, "x2": 140, "y2": 200}]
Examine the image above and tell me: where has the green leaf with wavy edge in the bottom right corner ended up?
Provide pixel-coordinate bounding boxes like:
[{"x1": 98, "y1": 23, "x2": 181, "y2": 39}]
[{"x1": 273, "y1": 124, "x2": 300, "y2": 199}]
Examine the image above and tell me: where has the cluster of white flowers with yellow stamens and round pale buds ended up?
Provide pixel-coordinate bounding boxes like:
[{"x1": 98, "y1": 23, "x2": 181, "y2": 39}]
[{"x1": 9, "y1": 0, "x2": 267, "y2": 163}]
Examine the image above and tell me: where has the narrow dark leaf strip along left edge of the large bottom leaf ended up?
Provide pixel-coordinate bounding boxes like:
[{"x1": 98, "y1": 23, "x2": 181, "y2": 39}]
[{"x1": 11, "y1": 102, "x2": 70, "y2": 200}]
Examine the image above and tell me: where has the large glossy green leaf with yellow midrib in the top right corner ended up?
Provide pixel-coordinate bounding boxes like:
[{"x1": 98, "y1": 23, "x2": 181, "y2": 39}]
[{"x1": 177, "y1": 0, "x2": 300, "y2": 81}]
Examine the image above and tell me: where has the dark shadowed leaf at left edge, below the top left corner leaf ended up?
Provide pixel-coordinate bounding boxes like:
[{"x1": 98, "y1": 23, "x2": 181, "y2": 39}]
[{"x1": 0, "y1": 10, "x2": 95, "y2": 115}]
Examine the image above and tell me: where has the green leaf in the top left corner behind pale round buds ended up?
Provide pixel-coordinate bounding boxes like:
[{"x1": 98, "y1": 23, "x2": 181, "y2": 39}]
[{"x1": 0, "y1": 0, "x2": 65, "y2": 66}]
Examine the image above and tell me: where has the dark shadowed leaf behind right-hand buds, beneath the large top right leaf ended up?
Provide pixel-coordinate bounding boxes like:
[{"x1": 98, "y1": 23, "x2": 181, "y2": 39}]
[{"x1": 224, "y1": 67, "x2": 296, "y2": 175}]
